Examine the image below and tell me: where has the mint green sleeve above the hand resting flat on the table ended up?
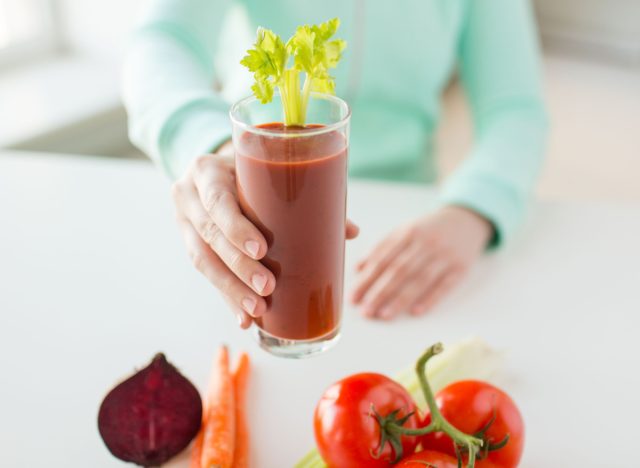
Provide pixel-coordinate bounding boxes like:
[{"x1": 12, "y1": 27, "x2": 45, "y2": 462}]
[{"x1": 440, "y1": 0, "x2": 548, "y2": 247}]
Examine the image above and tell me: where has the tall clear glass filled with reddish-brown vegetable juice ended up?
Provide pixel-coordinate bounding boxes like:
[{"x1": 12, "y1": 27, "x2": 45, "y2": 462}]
[{"x1": 230, "y1": 93, "x2": 350, "y2": 358}]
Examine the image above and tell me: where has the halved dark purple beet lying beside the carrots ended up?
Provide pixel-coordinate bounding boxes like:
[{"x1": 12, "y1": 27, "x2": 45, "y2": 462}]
[{"x1": 98, "y1": 354, "x2": 202, "y2": 466}]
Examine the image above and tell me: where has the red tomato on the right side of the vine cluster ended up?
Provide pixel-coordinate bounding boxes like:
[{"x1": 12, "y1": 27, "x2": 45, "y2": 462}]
[{"x1": 420, "y1": 380, "x2": 524, "y2": 468}]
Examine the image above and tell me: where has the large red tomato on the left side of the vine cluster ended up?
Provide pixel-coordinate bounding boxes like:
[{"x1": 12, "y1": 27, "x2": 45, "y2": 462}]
[{"x1": 314, "y1": 373, "x2": 420, "y2": 468}]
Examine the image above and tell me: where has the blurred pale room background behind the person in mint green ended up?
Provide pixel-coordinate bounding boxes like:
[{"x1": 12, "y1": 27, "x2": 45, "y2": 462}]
[{"x1": 0, "y1": 0, "x2": 640, "y2": 200}]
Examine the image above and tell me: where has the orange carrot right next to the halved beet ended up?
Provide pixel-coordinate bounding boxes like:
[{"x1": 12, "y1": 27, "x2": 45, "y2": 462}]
[{"x1": 201, "y1": 346, "x2": 236, "y2": 468}]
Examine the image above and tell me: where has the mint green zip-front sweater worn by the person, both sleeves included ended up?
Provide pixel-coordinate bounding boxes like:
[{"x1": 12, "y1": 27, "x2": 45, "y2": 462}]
[{"x1": 124, "y1": 0, "x2": 547, "y2": 247}]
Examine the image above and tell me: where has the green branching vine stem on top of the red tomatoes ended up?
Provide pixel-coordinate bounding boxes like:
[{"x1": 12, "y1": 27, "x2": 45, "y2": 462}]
[{"x1": 386, "y1": 343, "x2": 483, "y2": 468}]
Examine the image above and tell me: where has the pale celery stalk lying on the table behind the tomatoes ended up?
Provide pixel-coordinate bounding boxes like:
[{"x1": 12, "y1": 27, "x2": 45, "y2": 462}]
[{"x1": 295, "y1": 338, "x2": 504, "y2": 468}]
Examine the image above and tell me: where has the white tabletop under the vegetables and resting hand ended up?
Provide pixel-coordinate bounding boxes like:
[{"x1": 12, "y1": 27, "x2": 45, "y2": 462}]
[{"x1": 0, "y1": 153, "x2": 640, "y2": 468}]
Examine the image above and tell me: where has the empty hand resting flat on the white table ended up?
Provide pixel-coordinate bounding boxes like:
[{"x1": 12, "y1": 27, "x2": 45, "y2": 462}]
[{"x1": 352, "y1": 206, "x2": 493, "y2": 320}]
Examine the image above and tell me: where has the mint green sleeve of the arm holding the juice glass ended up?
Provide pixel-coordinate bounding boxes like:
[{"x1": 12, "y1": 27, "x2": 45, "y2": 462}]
[{"x1": 123, "y1": 0, "x2": 231, "y2": 178}]
